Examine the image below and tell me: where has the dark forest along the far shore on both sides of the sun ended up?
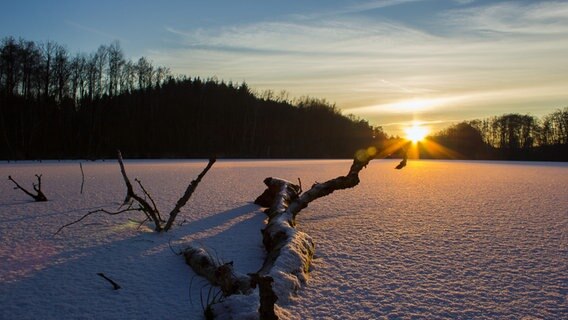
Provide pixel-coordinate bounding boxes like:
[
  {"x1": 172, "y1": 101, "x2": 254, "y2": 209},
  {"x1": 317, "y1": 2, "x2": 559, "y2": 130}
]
[{"x1": 0, "y1": 37, "x2": 568, "y2": 161}]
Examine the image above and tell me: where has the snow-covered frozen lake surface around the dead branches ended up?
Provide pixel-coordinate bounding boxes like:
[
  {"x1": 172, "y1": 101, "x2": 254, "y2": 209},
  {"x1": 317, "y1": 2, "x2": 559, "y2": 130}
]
[{"x1": 0, "y1": 160, "x2": 568, "y2": 319}]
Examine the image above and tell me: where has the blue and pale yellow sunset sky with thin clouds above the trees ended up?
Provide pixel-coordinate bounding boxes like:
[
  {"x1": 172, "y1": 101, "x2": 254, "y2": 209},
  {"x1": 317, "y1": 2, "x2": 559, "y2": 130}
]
[{"x1": 0, "y1": 0, "x2": 568, "y2": 135}]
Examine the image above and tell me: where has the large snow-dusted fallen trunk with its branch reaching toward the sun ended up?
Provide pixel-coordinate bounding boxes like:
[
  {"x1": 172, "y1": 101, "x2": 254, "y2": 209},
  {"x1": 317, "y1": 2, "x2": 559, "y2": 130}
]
[{"x1": 184, "y1": 148, "x2": 407, "y2": 319}]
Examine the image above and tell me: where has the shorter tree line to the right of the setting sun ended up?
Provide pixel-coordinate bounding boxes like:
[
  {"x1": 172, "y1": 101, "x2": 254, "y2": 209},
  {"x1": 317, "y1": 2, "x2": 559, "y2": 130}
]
[{"x1": 421, "y1": 107, "x2": 568, "y2": 161}]
